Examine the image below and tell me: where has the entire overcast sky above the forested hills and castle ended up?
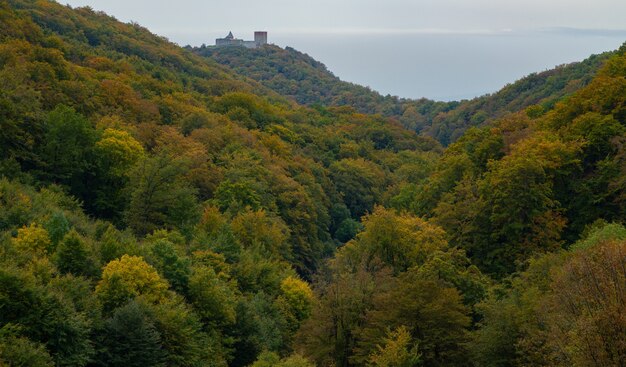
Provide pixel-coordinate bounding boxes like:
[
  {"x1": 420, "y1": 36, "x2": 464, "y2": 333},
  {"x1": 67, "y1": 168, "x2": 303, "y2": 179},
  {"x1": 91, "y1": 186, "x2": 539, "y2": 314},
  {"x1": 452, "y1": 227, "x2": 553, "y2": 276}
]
[{"x1": 61, "y1": 0, "x2": 626, "y2": 100}]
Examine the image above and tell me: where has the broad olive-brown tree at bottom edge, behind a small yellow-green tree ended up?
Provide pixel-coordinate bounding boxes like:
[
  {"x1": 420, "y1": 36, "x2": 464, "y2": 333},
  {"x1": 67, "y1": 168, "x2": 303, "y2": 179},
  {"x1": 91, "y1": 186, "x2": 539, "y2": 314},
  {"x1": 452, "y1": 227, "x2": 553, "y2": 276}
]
[{"x1": 352, "y1": 267, "x2": 471, "y2": 366}]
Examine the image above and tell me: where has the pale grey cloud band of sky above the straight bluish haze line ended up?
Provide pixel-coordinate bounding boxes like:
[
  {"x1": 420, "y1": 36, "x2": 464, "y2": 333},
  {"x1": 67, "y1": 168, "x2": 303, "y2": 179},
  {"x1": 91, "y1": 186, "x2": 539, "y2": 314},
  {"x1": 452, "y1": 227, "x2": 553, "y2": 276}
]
[{"x1": 65, "y1": 0, "x2": 626, "y2": 44}]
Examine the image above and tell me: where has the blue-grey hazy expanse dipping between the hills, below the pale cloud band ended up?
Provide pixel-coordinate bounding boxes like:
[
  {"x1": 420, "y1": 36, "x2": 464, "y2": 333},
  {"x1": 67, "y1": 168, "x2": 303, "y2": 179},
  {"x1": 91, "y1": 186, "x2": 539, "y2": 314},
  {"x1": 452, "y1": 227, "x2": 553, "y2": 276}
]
[{"x1": 269, "y1": 29, "x2": 626, "y2": 101}]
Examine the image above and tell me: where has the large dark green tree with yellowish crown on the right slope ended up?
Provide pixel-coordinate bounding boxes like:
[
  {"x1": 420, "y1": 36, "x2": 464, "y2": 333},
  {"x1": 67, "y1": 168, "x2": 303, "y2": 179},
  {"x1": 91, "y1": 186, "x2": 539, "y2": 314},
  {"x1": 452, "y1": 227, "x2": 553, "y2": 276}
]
[{"x1": 464, "y1": 133, "x2": 578, "y2": 276}]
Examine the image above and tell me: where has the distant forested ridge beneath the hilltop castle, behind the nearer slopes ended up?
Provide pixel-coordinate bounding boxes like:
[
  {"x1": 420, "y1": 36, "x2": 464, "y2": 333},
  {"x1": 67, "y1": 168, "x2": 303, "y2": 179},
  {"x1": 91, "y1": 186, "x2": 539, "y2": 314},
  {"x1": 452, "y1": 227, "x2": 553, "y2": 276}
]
[{"x1": 193, "y1": 45, "x2": 614, "y2": 145}]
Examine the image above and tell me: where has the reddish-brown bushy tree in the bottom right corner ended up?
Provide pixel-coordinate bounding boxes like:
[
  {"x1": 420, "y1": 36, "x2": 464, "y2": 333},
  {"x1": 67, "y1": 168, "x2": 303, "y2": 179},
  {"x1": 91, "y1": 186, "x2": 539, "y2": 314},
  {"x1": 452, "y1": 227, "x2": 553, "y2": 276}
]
[{"x1": 538, "y1": 240, "x2": 626, "y2": 366}]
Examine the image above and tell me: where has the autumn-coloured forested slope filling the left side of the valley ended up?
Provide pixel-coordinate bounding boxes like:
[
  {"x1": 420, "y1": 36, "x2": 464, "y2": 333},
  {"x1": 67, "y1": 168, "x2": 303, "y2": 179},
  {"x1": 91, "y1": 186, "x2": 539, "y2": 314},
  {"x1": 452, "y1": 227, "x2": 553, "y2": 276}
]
[{"x1": 0, "y1": 0, "x2": 441, "y2": 367}]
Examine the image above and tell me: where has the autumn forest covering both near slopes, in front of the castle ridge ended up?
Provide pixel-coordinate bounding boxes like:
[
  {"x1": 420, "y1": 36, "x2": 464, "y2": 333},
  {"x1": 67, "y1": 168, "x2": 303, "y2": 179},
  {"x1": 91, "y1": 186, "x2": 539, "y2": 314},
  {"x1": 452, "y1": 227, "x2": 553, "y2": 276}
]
[{"x1": 0, "y1": 0, "x2": 626, "y2": 367}]
